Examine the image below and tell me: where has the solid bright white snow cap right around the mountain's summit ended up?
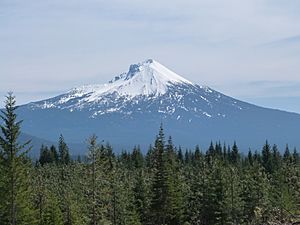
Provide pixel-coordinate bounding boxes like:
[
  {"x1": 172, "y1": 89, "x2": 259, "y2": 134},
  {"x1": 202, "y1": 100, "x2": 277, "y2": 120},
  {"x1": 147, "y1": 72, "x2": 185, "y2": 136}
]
[{"x1": 71, "y1": 59, "x2": 193, "y2": 101}]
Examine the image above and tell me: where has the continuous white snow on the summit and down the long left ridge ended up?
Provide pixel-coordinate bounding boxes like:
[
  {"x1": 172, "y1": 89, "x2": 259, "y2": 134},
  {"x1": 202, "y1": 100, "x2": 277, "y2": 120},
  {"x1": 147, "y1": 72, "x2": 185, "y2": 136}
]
[{"x1": 31, "y1": 59, "x2": 211, "y2": 110}]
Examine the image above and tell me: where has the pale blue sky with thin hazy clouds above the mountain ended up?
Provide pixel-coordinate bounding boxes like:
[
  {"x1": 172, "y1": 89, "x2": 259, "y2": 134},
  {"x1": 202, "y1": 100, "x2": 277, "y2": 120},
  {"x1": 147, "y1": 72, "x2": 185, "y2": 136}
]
[{"x1": 0, "y1": 0, "x2": 300, "y2": 113}]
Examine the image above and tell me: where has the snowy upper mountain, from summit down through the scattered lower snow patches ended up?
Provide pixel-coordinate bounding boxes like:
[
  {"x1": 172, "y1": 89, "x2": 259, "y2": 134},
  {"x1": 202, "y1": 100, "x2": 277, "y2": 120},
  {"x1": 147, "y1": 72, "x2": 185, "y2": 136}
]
[{"x1": 30, "y1": 59, "x2": 247, "y2": 120}]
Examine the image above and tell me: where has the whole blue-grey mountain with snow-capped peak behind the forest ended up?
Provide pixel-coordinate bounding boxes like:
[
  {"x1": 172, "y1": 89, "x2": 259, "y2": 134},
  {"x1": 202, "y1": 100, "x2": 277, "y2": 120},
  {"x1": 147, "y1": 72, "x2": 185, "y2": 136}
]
[{"x1": 18, "y1": 59, "x2": 300, "y2": 152}]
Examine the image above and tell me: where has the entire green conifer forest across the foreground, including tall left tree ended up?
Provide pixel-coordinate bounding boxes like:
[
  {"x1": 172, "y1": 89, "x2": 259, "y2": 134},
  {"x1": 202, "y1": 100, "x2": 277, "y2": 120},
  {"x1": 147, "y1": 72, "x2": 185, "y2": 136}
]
[{"x1": 0, "y1": 94, "x2": 300, "y2": 225}]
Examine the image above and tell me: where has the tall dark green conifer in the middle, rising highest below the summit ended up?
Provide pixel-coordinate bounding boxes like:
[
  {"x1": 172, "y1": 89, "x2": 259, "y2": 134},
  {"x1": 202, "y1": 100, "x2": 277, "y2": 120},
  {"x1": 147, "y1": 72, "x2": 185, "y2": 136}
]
[{"x1": 150, "y1": 126, "x2": 185, "y2": 225}]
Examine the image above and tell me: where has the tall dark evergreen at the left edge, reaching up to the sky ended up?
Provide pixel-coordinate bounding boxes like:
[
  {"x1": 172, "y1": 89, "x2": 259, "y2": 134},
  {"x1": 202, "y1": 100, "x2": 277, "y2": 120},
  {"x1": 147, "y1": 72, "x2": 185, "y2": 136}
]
[{"x1": 0, "y1": 93, "x2": 36, "y2": 225}]
